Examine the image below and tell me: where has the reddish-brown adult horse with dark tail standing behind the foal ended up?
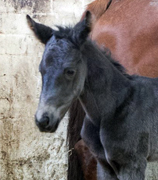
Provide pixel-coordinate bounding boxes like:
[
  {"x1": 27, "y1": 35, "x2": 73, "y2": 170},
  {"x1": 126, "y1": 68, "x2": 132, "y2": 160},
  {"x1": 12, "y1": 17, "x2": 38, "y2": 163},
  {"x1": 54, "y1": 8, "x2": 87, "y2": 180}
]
[{"x1": 68, "y1": 0, "x2": 158, "y2": 180}]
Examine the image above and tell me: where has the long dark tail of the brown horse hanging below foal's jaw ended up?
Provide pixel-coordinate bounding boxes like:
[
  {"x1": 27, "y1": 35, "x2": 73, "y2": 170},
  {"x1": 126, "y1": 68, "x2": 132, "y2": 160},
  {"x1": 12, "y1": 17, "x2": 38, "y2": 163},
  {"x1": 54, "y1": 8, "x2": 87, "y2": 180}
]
[{"x1": 67, "y1": 100, "x2": 85, "y2": 180}]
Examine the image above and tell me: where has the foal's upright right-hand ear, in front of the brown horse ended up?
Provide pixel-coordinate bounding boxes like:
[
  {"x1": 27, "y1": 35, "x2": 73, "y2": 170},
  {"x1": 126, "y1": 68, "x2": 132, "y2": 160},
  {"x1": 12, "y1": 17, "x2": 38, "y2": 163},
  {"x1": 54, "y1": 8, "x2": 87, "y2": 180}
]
[{"x1": 73, "y1": 11, "x2": 92, "y2": 44}]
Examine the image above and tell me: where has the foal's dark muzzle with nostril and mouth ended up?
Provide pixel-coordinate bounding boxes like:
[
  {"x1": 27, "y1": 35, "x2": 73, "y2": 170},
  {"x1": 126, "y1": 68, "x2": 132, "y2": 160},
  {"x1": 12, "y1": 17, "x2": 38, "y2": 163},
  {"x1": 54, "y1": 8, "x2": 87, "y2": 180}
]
[{"x1": 35, "y1": 113, "x2": 59, "y2": 133}]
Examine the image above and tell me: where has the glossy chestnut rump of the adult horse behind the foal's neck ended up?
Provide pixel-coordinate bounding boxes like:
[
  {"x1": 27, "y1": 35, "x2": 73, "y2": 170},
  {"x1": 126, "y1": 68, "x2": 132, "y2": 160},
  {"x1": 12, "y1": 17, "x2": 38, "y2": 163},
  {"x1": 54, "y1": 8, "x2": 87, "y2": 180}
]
[{"x1": 91, "y1": 0, "x2": 158, "y2": 77}]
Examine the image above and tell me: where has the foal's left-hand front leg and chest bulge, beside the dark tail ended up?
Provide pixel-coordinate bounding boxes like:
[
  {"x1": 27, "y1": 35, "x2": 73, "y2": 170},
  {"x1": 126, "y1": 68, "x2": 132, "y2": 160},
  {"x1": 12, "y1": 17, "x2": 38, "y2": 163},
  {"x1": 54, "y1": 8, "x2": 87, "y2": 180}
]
[{"x1": 81, "y1": 116, "x2": 118, "y2": 180}]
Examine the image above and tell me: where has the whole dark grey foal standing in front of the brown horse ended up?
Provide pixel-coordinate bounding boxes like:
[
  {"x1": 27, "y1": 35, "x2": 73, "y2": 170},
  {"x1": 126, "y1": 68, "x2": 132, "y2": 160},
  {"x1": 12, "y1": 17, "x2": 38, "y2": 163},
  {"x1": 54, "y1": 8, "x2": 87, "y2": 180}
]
[{"x1": 27, "y1": 12, "x2": 158, "y2": 180}]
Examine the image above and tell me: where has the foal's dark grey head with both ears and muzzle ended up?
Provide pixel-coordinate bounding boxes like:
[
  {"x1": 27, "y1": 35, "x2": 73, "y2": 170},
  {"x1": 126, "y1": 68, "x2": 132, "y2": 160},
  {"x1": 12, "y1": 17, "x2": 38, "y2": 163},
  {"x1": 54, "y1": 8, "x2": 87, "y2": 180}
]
[{"x1": 27, "y1": 12, "x2": 91, "y2": 132}]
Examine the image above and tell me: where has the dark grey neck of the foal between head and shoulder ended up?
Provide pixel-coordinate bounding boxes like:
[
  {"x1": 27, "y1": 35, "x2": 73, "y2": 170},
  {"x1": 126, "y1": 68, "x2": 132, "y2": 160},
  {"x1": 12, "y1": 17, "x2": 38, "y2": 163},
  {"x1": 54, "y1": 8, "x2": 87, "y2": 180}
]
[{"x1": 80, "y1": 42, "x2": 131, "y2": 125}]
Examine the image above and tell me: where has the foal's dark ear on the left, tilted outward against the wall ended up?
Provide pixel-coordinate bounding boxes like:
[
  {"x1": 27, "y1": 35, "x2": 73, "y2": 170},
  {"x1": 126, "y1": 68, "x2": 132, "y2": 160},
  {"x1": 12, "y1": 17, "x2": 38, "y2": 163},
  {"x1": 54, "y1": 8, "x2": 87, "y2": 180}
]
[{"x1": 26, "y1": 15, "x2": 53, "y2": 44}]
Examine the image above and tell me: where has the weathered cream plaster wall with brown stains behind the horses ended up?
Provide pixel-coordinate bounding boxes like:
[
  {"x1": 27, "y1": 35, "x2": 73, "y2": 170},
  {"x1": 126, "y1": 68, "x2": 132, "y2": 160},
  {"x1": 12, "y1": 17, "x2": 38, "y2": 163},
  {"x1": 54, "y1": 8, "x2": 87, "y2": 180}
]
[{"x1": 0, "y1": 0, "x2": 158, "y2": 180}]
